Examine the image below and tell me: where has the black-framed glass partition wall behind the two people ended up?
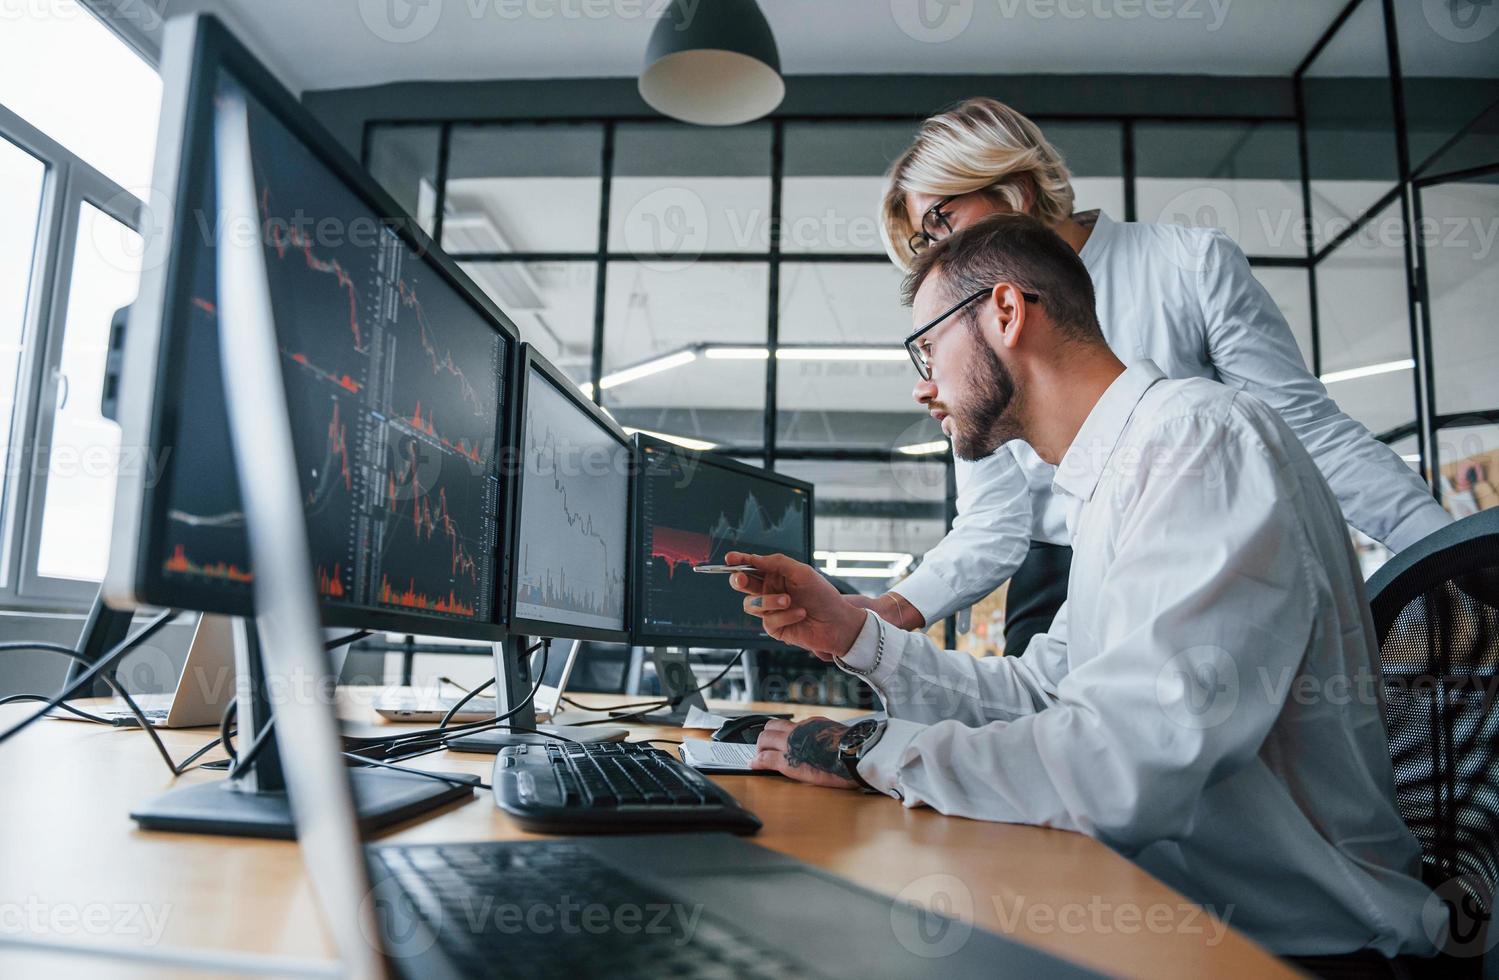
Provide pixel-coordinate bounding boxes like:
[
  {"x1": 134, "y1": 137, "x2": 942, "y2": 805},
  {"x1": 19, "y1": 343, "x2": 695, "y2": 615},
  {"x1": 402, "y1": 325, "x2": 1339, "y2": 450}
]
[{"x1": 366, "y1": 105, "x2": 1337, "y2": 623}]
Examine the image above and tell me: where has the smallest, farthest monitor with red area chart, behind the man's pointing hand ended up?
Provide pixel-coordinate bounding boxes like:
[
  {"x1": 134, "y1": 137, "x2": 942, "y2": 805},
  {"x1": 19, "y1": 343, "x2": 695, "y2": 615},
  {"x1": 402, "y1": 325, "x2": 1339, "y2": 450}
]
[{"x1": 634, "y1": 435, "x2": 812, "y2": 647}]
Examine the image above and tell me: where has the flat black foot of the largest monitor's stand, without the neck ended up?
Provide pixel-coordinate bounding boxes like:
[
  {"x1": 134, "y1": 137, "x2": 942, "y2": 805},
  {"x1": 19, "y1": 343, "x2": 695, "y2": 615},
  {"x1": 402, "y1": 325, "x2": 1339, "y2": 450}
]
[{"x1": 130, "y1": 769, "x2": 480, "y2": 841}]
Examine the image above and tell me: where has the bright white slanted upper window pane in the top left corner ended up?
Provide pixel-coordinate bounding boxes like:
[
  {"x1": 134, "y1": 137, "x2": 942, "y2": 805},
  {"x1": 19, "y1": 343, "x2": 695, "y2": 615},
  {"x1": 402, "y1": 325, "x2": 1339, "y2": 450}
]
[{"x1": 0, "y1": 0, "x2": 162, "y2": 191}]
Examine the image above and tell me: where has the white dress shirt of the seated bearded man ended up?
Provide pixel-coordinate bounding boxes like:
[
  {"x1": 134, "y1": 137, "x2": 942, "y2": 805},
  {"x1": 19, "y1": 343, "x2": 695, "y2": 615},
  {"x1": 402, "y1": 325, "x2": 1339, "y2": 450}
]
[{"x1": 841, "y1": 361, "x2": 1433, "y2": 956}]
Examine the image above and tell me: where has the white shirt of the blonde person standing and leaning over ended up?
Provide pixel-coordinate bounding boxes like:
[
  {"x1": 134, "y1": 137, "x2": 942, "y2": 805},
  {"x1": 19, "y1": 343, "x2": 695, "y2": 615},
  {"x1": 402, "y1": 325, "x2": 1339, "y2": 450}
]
[{"x1": 895, "y1": 211, "x2": 1451, "y2": 623}]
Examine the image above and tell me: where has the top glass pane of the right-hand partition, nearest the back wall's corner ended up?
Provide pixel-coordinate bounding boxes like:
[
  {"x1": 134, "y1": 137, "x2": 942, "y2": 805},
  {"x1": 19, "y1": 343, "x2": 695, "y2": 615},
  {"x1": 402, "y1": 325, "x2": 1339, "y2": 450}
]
[{"x1": 1301, "y1": 0, "x2": 1400, "y2": 247}]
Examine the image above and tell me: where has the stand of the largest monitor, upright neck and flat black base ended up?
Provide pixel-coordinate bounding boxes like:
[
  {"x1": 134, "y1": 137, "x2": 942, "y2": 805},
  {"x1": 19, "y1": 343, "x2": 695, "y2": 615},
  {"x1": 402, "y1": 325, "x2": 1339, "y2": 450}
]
[{"x1": 130, "y1": 619, "x2": 480, "y2": 841}]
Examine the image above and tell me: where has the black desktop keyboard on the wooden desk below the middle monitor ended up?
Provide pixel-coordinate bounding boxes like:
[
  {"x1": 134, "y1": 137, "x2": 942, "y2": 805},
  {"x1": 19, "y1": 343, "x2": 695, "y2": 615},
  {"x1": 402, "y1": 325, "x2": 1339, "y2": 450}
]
[{"x1": 493, "y1": 742, "x2": 760, "y2": 833}]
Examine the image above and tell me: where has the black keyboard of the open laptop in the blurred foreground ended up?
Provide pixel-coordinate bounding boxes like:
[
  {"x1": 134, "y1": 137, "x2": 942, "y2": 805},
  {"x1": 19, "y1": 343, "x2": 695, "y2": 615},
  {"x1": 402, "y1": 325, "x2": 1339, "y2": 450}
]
[{"x1": 369, "y1": 841, "x2": 806, "y2": 980}]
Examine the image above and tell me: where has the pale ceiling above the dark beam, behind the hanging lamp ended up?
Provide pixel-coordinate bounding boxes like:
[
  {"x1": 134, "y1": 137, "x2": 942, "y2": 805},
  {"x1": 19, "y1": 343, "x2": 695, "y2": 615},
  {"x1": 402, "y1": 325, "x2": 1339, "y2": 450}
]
[{"x1": 108, "y1": 0, "x2": 1343, "y2": 90}]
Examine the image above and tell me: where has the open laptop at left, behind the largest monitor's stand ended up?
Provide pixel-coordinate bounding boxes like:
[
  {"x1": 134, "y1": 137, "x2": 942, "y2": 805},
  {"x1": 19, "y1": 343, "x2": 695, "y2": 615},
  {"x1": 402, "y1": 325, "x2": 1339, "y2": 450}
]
[{"x1": 51, "y1": 613, "x2": 234, "y2": 728}]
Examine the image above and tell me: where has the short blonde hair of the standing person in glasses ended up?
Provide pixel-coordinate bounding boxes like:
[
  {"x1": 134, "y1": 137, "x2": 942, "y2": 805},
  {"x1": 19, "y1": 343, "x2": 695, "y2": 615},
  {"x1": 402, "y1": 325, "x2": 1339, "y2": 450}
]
[{"x1": 880, "y1": 97, "x2": 1073, "y2": 268}]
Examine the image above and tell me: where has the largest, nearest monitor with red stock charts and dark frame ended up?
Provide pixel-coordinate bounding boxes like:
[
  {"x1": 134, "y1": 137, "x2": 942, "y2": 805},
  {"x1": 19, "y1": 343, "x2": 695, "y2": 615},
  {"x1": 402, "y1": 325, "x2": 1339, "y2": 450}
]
[{"x1": 106, "y1": 18, "x2": 519, "y2": 640}]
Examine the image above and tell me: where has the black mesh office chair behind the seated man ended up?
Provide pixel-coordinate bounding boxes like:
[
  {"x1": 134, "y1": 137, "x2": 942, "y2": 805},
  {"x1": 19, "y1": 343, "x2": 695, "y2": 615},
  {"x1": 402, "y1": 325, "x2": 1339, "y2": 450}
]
[{"x1": 1367, "y1": 509, "x2": 1499, "y2": 976}]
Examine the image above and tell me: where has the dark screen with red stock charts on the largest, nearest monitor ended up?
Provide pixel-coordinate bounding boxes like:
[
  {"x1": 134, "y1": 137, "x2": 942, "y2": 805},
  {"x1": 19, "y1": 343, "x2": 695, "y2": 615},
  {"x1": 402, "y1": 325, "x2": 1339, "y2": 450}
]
[{"x1": 159, "y1": 82, "x2": 508, "y2": 622}]
